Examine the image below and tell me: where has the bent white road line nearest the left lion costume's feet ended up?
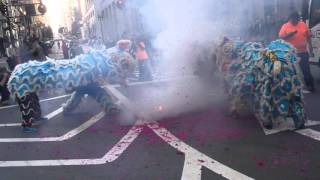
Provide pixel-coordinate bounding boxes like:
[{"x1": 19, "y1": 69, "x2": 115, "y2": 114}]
[{"x1": 0, "y1": 112, "x2": 105, "y2": 143}]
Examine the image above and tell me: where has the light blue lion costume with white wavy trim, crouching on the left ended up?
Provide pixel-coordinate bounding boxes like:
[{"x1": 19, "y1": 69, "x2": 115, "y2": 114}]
[{"x1": 8, "y1": 41, "x2": 133, "y2": 131}]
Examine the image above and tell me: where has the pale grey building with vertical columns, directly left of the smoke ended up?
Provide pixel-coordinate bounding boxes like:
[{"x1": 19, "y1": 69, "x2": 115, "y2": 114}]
[{"x1": 81, "y1": 0, "x2": 143, "y2": 42}]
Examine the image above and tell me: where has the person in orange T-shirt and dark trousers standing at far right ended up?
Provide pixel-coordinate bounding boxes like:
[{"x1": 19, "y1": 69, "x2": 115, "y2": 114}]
[{"x1": 279, "y1": 12, "x2": 315, "y2": 92}]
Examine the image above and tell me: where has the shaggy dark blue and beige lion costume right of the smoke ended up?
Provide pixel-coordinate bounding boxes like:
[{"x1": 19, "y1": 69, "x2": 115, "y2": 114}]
[{"x1": 217, "y1": 40, "x2": 306, "y2": 129}]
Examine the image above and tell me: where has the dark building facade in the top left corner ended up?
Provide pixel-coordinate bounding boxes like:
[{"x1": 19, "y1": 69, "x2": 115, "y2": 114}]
[{"x1": 0, "y1": 0, "x2": 52, "y2": 64}]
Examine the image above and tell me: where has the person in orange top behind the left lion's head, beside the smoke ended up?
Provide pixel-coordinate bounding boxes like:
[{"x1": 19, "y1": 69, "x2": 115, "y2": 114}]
[{"x1": 135, "y1": 41, "x2": 152, "y2": 81}]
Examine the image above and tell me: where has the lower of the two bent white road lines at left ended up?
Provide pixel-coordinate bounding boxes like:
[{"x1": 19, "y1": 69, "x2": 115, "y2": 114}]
[{"x1": 0, "y1": 126, "x2": 143, "y2": 167}]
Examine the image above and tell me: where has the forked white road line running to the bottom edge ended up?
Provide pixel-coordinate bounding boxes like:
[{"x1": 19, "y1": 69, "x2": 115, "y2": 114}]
[{"x1": 148, "y1": 123, "x2": 253, "y2": 180}]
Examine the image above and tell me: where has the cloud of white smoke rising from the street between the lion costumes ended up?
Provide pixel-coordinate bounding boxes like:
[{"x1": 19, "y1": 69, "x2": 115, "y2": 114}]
[{"x1": 120, "y1": 0, "x2": 252, "y2": 124}]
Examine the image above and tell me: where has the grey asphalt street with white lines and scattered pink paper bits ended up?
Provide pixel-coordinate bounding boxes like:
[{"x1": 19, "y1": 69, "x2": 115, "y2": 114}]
[{"x1": 0, "y1": 75, "x2": 320, "y2": 180}]
